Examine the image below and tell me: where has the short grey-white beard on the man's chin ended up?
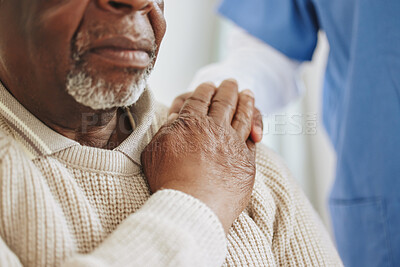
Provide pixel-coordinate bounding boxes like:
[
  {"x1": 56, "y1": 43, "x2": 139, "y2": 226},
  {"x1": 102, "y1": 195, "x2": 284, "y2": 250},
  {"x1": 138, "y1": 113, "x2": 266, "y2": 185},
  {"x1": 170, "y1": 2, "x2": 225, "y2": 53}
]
[{"x1": 66, "y1": 72, "x2": 147, "y2": 110}]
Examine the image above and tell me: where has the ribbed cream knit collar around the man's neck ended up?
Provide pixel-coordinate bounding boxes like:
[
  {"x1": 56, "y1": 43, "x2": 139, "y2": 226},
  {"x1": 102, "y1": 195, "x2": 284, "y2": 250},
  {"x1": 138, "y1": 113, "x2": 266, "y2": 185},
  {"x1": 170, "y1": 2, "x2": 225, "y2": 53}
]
[{"x1": 0, "y1": 82, "x2": 155, "y2": 171}]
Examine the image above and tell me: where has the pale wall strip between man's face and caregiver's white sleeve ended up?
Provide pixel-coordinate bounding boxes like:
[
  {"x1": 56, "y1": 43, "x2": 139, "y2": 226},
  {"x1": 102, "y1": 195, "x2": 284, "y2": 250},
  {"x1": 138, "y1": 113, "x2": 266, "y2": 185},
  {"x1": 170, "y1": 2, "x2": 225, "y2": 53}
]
[{"x1": 150, "y1": 0, "x2": 218, "y2": 104}]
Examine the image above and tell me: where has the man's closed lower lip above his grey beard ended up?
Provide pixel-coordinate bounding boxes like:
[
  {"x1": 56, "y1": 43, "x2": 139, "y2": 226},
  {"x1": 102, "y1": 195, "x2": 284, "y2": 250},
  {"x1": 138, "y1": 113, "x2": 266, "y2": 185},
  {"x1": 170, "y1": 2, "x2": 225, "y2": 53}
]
[{"x1": 92, "y1": 48, "x2": 150, "y2": 69}]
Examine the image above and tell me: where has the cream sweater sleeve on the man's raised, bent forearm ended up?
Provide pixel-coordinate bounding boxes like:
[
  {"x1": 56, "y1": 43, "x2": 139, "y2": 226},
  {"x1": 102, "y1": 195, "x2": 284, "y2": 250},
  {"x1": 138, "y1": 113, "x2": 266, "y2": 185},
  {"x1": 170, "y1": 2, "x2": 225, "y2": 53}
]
[{"x1": 63, "y1": 190, "x2": 226, "y2": 267}]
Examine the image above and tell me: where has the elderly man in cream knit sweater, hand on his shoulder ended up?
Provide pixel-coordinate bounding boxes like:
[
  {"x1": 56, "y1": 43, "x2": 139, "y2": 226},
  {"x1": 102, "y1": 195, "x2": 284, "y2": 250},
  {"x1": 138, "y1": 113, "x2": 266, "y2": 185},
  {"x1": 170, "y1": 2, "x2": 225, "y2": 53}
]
[{"x1": 0, "y1": 0, "x2": 341, "y2": 266}]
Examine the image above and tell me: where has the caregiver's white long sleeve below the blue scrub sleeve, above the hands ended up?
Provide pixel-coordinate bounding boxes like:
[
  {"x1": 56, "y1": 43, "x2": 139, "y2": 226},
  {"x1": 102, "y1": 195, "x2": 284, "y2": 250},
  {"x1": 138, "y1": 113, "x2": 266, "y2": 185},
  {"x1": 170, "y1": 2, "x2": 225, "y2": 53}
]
[{"x1": 189, "y1": 28, "x2": 302, "y2": 114}]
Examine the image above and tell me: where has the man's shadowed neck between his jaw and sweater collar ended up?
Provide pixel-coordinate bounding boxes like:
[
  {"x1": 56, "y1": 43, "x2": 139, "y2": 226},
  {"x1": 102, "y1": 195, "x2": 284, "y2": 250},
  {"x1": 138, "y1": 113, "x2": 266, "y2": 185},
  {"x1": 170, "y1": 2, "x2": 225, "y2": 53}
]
[{"x1": 0, "y1": 77, "x2": 134, "y2": 149}]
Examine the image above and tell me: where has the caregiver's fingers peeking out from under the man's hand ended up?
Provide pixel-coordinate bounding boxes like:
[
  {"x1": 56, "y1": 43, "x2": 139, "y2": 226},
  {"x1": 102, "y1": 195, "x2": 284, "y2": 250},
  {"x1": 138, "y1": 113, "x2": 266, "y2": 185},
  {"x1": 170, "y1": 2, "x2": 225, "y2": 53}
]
[{"x1": 168, "y1": 81, "x2": 263, "y2": 143}]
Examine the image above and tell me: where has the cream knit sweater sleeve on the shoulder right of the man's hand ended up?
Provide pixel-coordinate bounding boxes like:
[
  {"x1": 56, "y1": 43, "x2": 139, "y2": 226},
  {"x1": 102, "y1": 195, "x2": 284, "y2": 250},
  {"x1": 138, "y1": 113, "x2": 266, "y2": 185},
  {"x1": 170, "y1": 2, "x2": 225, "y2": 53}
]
[{"x1": 253, "y1": 146, "x2": 343, "y2": 266}]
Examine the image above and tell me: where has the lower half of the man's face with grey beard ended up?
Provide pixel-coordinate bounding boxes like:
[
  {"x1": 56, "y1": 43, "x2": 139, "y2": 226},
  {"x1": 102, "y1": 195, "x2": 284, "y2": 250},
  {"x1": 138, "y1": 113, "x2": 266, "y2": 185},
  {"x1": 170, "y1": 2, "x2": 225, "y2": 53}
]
[{"x1": 0, "y1": 0, "x2": 165, "y2": 109}]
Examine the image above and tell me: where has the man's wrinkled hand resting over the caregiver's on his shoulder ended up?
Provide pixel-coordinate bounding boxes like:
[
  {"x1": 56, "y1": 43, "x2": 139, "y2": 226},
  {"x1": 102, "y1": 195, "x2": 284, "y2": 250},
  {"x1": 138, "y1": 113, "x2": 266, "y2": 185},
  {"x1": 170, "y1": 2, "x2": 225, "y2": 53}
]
[{"x1": 142, "y1": 81, "x2": 255, "y2": 232}]
